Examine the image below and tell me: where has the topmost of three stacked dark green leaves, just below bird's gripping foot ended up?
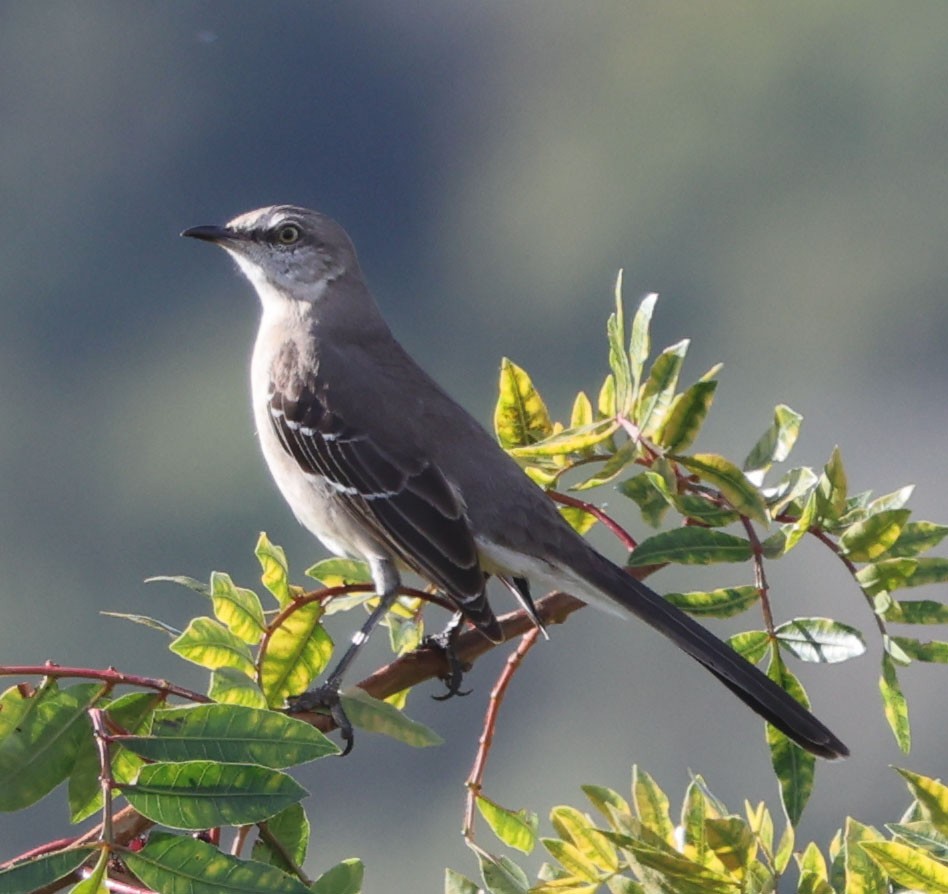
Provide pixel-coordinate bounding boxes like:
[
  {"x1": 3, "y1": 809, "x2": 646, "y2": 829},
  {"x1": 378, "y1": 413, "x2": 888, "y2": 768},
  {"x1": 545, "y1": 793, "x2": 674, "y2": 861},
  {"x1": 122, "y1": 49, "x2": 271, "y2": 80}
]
[{"x1": 116, "y1": 705, "x2": 339, "y2": 769}]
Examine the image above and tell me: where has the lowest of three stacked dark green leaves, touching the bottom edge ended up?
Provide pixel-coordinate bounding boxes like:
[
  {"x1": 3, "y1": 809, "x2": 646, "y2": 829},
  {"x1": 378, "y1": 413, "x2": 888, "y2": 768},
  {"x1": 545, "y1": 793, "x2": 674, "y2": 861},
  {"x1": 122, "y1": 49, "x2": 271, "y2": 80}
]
[{"x1": 122, "y1": 832, "x2": 310, "y2": 894}]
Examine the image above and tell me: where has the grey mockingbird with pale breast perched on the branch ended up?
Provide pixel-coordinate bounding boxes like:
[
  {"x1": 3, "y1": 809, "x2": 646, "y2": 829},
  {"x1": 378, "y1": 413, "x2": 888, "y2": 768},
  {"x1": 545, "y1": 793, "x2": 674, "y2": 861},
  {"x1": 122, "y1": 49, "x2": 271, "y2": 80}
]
[{"x1": 183, "y1": 205, "x2": 848, "y2": 758}]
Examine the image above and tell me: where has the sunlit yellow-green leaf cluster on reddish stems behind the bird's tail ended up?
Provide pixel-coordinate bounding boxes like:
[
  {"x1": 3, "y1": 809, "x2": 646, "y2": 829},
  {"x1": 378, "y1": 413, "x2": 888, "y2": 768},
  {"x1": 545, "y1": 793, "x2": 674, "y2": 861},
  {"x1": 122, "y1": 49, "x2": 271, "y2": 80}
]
[{"x1": 494, "y1": 288, "x2": 948, "y2": 823}]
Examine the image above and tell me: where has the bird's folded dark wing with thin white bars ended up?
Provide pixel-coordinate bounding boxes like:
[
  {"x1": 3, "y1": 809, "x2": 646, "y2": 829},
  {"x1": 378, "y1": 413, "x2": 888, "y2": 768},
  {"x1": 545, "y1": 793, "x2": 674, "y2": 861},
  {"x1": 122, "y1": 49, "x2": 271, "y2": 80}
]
[{"x1": 269, "y1": 374, "x2": 502, "y2": 640}]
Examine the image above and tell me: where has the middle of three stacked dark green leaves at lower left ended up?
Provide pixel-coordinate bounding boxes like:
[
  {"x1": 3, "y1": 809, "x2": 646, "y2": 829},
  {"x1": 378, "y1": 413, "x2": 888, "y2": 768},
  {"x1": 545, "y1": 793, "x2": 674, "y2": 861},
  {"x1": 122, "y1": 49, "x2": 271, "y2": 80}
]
[{"x1": 120, "y1": 761, "x2": 307, "y2": 829}]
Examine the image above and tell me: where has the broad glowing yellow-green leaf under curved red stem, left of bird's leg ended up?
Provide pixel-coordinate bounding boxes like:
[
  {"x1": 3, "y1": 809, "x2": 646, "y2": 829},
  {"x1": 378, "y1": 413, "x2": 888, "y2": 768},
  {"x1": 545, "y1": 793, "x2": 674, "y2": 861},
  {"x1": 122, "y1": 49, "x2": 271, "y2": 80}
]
[{"x1": 260, "y1": 602, "x2": 332, "y2": 707}]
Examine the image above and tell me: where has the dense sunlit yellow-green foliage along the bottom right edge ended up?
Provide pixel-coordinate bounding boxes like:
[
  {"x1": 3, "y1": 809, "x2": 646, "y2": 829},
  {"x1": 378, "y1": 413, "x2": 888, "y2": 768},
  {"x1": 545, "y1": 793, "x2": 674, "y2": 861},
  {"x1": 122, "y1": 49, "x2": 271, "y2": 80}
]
[{"x1": 444, "y1": 767, "x2": 948, "y2": 894}]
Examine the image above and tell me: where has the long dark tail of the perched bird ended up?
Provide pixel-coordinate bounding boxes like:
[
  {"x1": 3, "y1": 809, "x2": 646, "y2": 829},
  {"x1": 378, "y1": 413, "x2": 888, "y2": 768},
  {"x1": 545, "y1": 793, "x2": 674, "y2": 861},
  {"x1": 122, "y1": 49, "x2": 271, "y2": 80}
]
[{"x1": 572, "y1": 548, "x2": 849, "y2": 758}]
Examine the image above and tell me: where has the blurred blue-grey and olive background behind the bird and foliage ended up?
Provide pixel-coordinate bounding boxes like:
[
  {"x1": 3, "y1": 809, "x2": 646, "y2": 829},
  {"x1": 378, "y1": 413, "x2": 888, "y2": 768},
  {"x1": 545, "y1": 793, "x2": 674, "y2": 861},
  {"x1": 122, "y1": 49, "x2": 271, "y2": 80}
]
[{"x1": 0, "y1": 0, "x2": 948, "y2": 891}]
